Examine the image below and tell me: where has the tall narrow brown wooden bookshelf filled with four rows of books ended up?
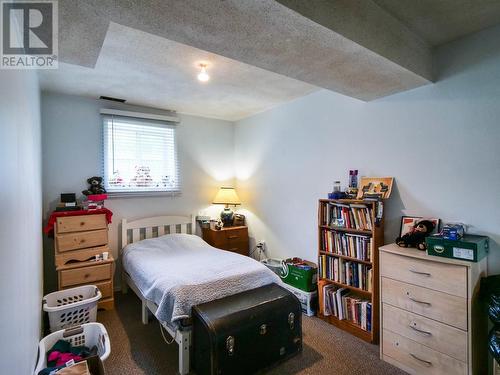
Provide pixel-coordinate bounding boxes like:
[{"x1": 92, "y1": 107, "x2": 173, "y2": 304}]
[{"x1": 318, "y1": 199, "x2": 384, "y2": 344}]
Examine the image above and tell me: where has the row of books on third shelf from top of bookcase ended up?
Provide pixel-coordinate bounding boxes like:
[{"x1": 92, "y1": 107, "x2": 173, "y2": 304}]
[{"x1": 318, "y1": 255, "x2": 373, "y2": 292}]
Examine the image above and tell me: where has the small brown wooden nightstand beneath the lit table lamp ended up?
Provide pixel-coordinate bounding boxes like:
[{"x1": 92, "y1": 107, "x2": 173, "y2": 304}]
[{"x1": 203, "y1": 226, "x2": 248, "y2": 255}]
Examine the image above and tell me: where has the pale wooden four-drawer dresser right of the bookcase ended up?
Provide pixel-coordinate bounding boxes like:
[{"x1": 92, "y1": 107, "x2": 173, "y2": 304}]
[{"x1": 380, "y1": 244, "x2": 487, "y2": 375}]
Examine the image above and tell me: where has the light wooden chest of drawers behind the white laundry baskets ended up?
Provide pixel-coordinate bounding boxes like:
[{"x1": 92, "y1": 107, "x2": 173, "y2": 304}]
[{"x1": 54, "y1": 214, "x2": 114, "y2": 309}]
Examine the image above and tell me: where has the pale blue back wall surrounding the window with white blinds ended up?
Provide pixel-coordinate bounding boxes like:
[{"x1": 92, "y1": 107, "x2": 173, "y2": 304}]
[{"x1": 42, "y1": 92, "x2": 234, "y2": 290}]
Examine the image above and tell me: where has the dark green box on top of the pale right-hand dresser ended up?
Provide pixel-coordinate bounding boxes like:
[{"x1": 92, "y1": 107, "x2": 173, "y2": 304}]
[{"x1": 425, "y1": 234, "x2": 489, "y2": 262}]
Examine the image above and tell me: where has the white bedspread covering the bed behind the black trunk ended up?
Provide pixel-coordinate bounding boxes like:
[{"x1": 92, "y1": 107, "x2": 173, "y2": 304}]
[{"x1": 122, "y1": 234, "x2": 281, "y2": 323}]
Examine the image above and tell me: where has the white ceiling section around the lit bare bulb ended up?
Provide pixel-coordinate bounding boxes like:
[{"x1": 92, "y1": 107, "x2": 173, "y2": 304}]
[{"x1": 40, "y1": 23, "x2": 318, "y2": 120}]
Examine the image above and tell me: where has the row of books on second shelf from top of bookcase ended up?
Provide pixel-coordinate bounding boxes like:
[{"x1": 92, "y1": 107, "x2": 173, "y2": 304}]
[{"x1": 321, "y1": 229, "x2": 373, "y2": 262}]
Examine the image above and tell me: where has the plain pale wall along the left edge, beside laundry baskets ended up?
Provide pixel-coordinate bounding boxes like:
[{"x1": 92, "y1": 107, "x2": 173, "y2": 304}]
[{"x1": 0, "y1": 70, "x2": 43, "y2": 375}]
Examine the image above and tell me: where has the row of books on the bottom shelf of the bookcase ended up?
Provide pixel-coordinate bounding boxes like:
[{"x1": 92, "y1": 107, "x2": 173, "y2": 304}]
[{"x1": 321, "y1": 284, "x2": 372, "y2": 332}]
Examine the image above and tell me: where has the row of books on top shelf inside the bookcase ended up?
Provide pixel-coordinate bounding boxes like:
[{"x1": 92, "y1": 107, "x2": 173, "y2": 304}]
[{"x1": 323, "y1": 202, "x2": 373, "y2": 230}]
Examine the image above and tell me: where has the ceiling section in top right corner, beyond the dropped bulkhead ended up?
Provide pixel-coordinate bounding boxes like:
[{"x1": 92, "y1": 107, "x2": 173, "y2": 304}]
[{"x1": 373, "y1": 0, "x2": 500, "y2": 46}]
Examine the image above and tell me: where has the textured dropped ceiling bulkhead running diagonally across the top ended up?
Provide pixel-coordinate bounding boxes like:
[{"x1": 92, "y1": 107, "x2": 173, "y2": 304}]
[{"x1": 55, "y1": 0, "x2": 432, "y2": 100}]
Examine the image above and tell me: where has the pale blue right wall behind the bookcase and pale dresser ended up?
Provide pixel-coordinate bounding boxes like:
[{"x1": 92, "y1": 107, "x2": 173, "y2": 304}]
[{"x1": 235, "y1": 27, "x2": 500, "y2": 273}]
